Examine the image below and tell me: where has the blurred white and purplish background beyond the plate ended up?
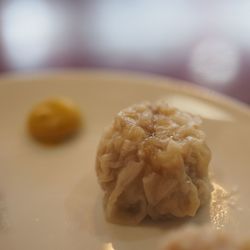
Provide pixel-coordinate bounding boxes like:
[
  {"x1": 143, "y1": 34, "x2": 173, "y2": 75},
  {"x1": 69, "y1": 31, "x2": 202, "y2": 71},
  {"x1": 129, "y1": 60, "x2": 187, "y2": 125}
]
[{"x1": 0, "y1": 0, "x2": 250, "y2": 104}]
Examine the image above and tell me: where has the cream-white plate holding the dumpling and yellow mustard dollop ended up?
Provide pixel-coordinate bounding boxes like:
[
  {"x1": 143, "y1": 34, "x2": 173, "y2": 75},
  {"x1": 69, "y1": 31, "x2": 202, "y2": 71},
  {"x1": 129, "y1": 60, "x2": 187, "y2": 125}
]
[{"x1": 0, "y1": 71, "x2": 250, "y2": 250}]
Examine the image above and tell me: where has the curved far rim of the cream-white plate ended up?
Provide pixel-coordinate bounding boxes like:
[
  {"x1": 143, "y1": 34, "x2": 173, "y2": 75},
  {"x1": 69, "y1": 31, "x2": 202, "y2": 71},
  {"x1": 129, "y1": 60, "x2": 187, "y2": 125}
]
[{"x1": 0, "y1": 68, "x2": 250, "y2": 118}]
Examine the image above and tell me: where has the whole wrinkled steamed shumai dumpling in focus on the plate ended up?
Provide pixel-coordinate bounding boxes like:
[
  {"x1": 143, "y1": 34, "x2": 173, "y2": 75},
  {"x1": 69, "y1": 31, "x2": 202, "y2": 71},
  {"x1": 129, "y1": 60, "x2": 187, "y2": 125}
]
[{"x1": 96, "y1": 101, "x2": 211, "y2": 224}]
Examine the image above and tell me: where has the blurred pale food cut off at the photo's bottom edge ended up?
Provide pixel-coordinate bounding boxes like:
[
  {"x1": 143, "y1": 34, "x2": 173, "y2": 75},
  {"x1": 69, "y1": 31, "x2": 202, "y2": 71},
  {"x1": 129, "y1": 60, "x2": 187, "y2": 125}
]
[{"x1": 161, "y1": 226, "x2": 250, "y2": 250}]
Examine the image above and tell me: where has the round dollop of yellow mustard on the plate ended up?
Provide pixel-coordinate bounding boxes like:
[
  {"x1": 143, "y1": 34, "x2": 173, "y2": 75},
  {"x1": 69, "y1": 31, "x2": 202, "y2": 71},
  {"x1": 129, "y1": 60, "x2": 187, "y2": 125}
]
[{"x1": 28, "y1": 98, "x2": 81, "y2": 143}]
